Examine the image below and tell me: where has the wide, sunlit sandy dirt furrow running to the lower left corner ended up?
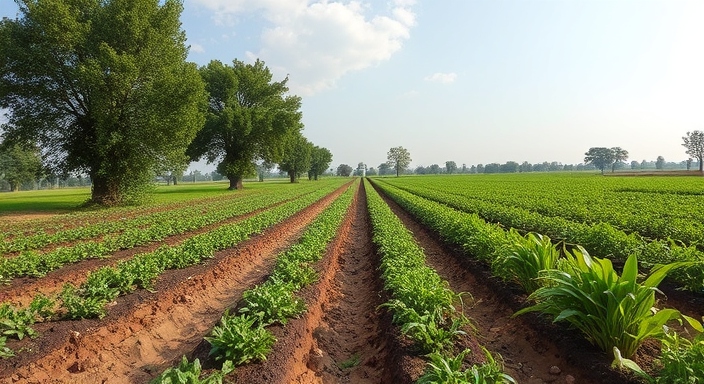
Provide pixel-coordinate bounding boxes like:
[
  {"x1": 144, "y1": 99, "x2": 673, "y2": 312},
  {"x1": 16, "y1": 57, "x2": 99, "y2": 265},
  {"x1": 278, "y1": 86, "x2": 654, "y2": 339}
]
[{"x1": 0, "y1": 185, "x2": 346, "y2": 384}]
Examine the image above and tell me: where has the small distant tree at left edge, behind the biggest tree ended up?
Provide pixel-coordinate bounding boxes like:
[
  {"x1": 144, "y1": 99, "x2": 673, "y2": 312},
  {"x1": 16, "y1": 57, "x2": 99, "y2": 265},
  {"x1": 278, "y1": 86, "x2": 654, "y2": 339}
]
[{"x1": 0, "y1": 143, "x2": 42, "y2": 191}]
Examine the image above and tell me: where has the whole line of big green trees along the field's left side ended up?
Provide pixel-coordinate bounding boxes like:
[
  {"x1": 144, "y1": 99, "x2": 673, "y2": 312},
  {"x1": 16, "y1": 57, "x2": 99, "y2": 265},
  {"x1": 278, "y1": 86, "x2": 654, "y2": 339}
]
[{"x1": 0, "y1": 0, "x2": 332, "y2": 205}]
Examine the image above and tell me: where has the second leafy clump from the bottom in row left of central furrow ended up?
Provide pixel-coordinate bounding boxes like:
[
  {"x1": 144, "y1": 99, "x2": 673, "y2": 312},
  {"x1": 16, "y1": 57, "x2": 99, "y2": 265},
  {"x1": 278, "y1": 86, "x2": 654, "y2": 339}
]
[{"x1": 205, "y1": 312, "x2": 276, "y2": 365}]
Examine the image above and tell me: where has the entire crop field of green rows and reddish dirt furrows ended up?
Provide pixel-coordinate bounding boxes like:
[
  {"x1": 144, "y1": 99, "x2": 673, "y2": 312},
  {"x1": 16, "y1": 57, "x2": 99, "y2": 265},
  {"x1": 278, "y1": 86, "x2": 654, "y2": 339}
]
[{"x1": 0, "y1": 173, "x2": 704, "y2": 384}]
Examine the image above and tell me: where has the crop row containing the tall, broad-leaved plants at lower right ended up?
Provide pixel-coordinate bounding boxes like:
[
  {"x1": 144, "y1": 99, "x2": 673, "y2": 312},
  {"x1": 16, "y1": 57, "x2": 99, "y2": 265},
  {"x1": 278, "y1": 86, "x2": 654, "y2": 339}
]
[{"x1": 368, "y1": 184, "x2": 704, "y2": 383}]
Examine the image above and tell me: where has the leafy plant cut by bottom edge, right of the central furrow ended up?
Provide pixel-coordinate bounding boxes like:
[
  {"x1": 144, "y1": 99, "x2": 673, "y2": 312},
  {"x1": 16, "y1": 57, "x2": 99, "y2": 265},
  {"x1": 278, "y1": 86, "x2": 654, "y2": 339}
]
[{"x1": 416, "y1": 349, "x2": 516, "y2": 384}]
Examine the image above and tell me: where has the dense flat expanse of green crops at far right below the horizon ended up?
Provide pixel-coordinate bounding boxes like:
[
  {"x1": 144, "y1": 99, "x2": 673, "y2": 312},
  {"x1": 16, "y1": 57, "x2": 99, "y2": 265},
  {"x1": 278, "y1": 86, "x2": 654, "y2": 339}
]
[{"x1": 382, "y1": 175, "x2": 704, "y2": 247}]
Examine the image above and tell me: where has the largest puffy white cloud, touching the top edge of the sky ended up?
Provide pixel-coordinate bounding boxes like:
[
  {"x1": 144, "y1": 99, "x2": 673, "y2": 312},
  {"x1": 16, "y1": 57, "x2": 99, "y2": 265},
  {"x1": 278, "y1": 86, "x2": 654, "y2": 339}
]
[{"x1": 190, "y1": 0, "x2": 416, "y2": 95}]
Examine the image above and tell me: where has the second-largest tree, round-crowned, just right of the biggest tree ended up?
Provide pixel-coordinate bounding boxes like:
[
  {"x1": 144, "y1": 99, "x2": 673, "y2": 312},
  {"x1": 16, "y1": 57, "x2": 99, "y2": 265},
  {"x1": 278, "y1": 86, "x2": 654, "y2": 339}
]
[{"x1": 189, "y1": 60, "x2": 302, "y2": 189}]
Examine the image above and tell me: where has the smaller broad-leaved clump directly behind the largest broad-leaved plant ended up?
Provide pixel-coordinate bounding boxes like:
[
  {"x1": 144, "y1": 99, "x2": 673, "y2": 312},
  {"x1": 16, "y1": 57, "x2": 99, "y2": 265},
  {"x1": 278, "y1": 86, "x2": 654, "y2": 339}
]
[{"x1": 491, "y1": 229, "x2": 560, "y2": 293}]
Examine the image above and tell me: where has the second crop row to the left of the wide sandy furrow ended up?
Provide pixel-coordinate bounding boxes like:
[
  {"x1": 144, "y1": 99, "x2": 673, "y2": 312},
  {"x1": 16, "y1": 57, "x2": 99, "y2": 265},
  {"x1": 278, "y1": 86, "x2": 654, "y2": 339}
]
[{"x1": 0, "y1": 180, "x2": 337, "y2": 282}]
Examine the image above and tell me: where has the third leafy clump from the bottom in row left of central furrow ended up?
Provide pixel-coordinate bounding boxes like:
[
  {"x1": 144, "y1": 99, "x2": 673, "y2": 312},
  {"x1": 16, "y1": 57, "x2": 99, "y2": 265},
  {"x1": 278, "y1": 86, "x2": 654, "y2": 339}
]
[{"x1": 240, "y1": 282, "x2": 306, "y2": 326}]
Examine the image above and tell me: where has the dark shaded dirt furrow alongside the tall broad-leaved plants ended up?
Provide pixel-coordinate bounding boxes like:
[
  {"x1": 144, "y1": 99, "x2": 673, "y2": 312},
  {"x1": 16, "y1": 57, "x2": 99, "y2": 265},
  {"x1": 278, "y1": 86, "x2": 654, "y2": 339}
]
[{"x1": 380, "y1": 182, "x2": 640, "y2": 384}]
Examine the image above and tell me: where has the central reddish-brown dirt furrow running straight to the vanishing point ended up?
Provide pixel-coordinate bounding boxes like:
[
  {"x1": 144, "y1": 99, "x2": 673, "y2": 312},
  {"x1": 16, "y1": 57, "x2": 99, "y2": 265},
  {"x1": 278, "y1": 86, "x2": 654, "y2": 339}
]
[{"x1": 235, "y1": 182, "x2": 408, "y2": 384}]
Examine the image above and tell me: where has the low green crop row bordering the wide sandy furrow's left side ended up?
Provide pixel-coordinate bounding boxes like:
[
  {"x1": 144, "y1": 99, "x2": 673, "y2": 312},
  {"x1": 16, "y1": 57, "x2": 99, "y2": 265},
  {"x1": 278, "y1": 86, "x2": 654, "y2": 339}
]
[{"x1": 0, "y1": 180, "x2": 346, "y2": 356}]
